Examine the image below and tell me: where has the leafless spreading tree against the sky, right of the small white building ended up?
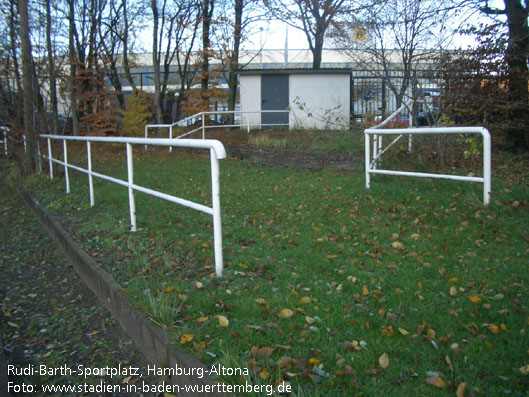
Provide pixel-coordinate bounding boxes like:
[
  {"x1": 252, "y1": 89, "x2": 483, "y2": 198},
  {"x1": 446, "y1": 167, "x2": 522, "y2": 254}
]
[{"x1": 339, "y1": 0, "x2": 455, "y2": 107}]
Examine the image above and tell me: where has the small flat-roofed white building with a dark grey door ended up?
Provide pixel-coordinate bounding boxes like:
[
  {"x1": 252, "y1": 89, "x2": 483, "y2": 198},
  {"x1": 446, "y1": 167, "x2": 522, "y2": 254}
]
[{"x1": 239, "y1": 69, "x2": 351, "y2": 129}]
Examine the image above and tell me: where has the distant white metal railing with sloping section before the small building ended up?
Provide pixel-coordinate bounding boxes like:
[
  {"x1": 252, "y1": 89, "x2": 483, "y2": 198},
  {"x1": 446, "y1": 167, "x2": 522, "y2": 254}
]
[{"x1": 145, "y1": 110, "x2": 291, "y2": 151}]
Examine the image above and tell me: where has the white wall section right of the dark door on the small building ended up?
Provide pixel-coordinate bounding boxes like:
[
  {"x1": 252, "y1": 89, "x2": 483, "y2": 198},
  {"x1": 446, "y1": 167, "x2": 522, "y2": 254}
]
[{"x1": 288, "y1": 74, "x2": 351, "y2": 129}]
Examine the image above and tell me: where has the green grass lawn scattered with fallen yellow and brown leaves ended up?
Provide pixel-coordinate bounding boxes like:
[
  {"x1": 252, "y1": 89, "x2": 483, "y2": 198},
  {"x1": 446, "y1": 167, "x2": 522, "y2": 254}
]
[{"x1": 25, "y1": 135, "x2": 529, "y2": 396}]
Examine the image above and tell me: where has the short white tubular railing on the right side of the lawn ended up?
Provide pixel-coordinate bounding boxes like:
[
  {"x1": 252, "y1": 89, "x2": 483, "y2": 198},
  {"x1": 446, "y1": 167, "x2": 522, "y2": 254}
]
[{"x1": 364, "y1": 127, "x2": 491, "y2": 205}]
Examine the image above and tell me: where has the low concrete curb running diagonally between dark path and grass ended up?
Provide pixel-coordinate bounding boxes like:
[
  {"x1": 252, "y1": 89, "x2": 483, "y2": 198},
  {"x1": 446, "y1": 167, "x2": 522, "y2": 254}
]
[{"x1": 19, "y1": 189, "x2": 223, "y2": 396}]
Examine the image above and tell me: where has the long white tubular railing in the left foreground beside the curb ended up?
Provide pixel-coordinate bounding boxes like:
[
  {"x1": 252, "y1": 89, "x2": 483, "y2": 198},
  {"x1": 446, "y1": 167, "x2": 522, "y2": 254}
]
[{"x1": 40, "y1": 135, "x2": 226, "y2": 277}]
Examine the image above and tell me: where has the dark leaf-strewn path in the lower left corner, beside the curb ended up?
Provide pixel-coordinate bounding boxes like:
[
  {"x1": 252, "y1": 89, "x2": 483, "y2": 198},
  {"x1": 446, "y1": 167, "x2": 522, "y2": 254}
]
[{"x1": 0, "y1": 158, "x2": 153, "y2": 396}]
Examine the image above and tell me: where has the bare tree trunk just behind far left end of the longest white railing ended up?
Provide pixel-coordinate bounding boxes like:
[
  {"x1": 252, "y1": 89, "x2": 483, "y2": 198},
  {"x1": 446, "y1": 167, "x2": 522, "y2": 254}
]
[{"x1": 18, "y1": 0, "x2": 37, "y2": 174}]
